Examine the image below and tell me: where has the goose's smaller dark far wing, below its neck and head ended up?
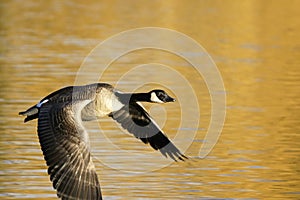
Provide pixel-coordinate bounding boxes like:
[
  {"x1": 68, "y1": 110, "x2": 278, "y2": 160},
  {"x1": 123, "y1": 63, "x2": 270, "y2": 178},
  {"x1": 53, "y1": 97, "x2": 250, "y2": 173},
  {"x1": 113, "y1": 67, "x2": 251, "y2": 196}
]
[{"x1": 109, "y1": 103, "x2": 187, "y2": 161}]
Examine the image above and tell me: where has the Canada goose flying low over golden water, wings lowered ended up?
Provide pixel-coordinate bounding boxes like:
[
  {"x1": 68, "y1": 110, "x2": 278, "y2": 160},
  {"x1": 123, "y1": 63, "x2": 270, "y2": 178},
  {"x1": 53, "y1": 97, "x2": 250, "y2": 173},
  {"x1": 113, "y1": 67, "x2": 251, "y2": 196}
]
[{"x1": 19, "y1": 83, "x2": 187, "y2": 200}]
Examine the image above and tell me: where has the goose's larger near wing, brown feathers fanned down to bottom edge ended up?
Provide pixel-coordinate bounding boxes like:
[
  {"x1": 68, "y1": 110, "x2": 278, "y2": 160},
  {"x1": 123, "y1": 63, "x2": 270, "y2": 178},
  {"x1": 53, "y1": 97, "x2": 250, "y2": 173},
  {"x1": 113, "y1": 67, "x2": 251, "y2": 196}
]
[{"x1": 38, "y1": 100, "x2": 102, "y2": 200}]
